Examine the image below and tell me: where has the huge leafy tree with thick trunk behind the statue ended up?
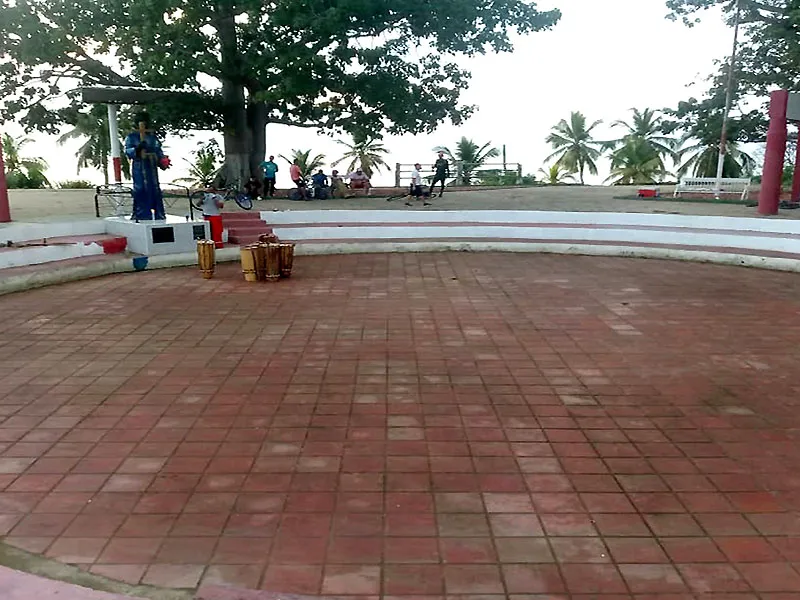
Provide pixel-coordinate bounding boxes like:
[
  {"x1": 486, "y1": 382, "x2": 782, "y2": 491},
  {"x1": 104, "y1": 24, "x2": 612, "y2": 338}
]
[{"x1": 0, "y1": 0, "x2": 560, "y2": 181}]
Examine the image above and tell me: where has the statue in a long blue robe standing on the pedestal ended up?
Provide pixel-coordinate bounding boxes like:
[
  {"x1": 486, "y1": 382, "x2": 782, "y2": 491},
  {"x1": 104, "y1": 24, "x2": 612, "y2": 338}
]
[{"x1": 125, "y1": 131, "x2": 166, "y2": 221}]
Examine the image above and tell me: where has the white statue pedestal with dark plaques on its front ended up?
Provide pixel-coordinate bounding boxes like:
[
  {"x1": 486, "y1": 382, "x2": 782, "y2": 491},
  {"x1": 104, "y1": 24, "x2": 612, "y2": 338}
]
[{"x1": 105, "y1": 215, "x2": 211, "y2": 256}]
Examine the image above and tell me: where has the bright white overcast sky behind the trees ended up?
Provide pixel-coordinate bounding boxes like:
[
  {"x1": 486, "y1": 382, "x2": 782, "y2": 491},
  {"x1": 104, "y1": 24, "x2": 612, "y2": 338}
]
[{"x1": 8, "y1": 0, "x2": 732, "y2": 186}]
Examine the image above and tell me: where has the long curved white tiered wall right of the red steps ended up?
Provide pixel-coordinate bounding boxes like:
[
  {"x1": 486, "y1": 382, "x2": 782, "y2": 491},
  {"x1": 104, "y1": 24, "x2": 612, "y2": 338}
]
[{"x1": 262, "y1": 210, "x2": 800, "y2": 255}]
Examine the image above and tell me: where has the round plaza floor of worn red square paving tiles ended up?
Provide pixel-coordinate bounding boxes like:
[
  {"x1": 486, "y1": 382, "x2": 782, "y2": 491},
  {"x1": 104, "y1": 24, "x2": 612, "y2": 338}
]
[{"x1": 0, "y1": 253, "x2": 800, "y2": 600}]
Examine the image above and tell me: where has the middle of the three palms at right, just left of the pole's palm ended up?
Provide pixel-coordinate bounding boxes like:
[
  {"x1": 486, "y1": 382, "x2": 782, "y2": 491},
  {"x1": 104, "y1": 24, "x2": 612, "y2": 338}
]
[{"x1": 605, "y1": 108, "x2": 677, "y2": 176}]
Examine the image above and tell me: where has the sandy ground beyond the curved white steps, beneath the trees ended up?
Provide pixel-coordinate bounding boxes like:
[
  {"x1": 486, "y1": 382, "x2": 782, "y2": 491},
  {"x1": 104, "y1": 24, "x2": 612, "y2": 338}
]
[{"x1": 4, "y1": 186, "x2": 800, "y2": 222}]
